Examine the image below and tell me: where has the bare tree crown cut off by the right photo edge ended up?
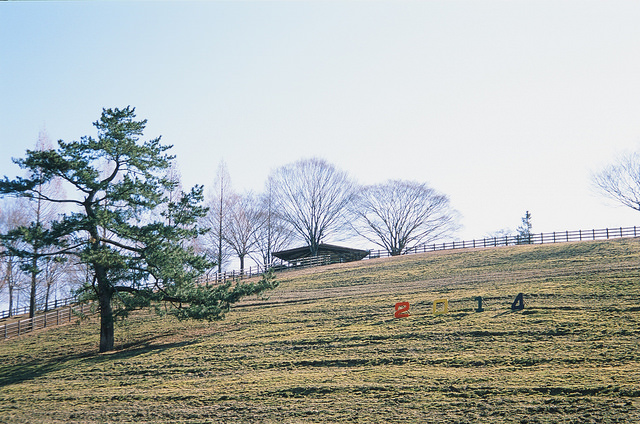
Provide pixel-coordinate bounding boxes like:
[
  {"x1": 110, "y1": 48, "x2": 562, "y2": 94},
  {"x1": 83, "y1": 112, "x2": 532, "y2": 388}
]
[{"x1": 593, "y1": 153, "x2": 640, "y2": 211}]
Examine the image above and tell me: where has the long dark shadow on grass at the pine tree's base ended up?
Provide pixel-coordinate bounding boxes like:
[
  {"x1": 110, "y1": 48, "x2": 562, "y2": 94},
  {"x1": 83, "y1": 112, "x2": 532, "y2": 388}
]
[{"x1": 0, "y1": 336, "x2": 197, "y2": 388}]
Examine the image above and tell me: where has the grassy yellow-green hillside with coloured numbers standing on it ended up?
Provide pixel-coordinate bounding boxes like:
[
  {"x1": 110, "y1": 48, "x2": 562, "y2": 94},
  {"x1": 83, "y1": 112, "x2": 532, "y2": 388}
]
[{"x1": 0, "y1": 239, "x2": 640, "y2": 423}]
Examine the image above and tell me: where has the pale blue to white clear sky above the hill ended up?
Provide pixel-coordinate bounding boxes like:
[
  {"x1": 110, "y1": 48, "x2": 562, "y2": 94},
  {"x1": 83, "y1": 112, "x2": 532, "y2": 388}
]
[{"x1": 0, "y1": 0, "x2": 640, "y2": 248}]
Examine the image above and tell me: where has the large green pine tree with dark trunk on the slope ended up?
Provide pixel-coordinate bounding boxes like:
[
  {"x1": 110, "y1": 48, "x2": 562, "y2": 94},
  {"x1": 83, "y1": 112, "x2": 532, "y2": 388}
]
[{"x1": 0, "y1": 107, "x2": 276, "y2": 352}]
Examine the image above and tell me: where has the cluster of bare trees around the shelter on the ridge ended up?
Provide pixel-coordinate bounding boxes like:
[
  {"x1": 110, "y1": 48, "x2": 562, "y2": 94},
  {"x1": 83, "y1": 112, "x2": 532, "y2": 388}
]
[{"x1": 199, "y1": 158, "x2": 458, "y2": 271}]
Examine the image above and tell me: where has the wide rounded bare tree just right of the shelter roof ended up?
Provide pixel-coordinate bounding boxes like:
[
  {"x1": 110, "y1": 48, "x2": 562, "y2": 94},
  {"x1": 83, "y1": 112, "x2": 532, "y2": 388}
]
[{"x1": 351, "y1": 180, "x2": 457, "y2": 256}]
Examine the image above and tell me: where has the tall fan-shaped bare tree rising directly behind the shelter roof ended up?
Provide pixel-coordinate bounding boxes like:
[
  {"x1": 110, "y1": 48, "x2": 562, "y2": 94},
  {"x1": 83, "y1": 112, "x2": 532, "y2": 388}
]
[{"x1": 271, "y1": 158, "x2": 355, "y2": 256}]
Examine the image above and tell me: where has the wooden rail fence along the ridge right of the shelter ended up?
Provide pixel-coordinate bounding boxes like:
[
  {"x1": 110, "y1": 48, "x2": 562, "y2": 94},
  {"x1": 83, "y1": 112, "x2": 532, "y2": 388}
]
[{"x1": 365, "y1": 226, "x2": 640, "y2": 259}]
